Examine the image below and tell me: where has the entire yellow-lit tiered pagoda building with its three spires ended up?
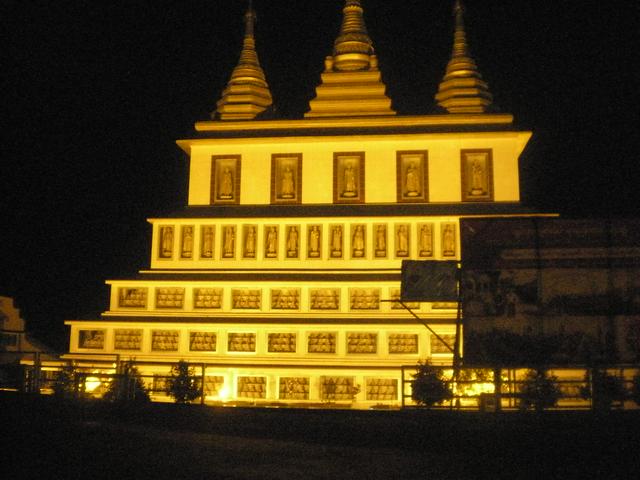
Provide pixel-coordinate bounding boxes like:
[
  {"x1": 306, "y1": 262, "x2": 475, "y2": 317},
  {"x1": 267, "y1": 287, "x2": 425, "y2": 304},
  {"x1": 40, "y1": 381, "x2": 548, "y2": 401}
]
[{"x1": 66, "y1": 0, "x2": 531, "y2": 407}]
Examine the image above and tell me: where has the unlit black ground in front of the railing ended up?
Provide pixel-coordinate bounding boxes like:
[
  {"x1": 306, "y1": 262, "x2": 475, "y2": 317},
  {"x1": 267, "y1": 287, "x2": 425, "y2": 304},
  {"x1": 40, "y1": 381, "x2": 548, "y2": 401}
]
[{"x1": 0, "y1": 394, "x2": 640, "y2": 480}]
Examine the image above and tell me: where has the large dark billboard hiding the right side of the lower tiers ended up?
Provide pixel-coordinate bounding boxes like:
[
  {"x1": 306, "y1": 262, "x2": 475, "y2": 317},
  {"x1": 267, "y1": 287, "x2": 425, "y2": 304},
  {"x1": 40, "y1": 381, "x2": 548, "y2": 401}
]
[{"x1": 460, "y1": 217, "x2": 640, "y2": 361}]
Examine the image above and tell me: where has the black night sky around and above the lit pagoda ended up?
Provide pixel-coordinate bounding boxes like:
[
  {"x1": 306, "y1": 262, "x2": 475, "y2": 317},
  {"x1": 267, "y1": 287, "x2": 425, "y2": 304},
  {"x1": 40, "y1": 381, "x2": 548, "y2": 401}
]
[{"x1": 0, "y1": 0, "x2": 640, "y2": 348}]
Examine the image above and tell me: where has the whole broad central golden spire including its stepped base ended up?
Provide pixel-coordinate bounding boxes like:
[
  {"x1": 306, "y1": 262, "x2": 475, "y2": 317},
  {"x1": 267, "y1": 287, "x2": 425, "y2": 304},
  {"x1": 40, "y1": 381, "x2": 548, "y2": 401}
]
[{"x1": 304, "y1": 0, "x2": 396, "y2": 118}]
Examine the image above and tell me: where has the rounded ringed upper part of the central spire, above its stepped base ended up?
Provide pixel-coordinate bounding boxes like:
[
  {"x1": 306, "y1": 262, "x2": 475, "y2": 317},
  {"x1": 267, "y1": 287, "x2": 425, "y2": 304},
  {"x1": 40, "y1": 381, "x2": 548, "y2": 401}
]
[{"x1": 333, "y1": 0, "x2": 373, "y2": 71}]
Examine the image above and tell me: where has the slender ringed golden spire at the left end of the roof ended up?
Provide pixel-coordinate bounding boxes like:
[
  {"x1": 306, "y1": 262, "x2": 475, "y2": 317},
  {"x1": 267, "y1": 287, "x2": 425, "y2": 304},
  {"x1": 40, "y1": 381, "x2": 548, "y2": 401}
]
[{"x1": 212, "y1": 1, "x2": 272, "y2": 120}]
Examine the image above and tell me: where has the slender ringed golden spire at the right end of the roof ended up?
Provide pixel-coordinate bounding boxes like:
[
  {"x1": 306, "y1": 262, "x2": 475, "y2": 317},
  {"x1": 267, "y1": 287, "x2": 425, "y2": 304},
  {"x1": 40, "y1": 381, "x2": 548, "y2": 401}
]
[{"x1": 436, "y1": 0, "x2": 493, "y2": 113}]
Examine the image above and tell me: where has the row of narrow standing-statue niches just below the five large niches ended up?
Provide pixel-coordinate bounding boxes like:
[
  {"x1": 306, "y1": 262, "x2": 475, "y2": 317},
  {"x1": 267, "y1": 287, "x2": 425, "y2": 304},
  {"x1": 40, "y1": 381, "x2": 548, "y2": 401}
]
[{"x1": 159, "y1": 224, "x2": 456, "y2": 259}]
